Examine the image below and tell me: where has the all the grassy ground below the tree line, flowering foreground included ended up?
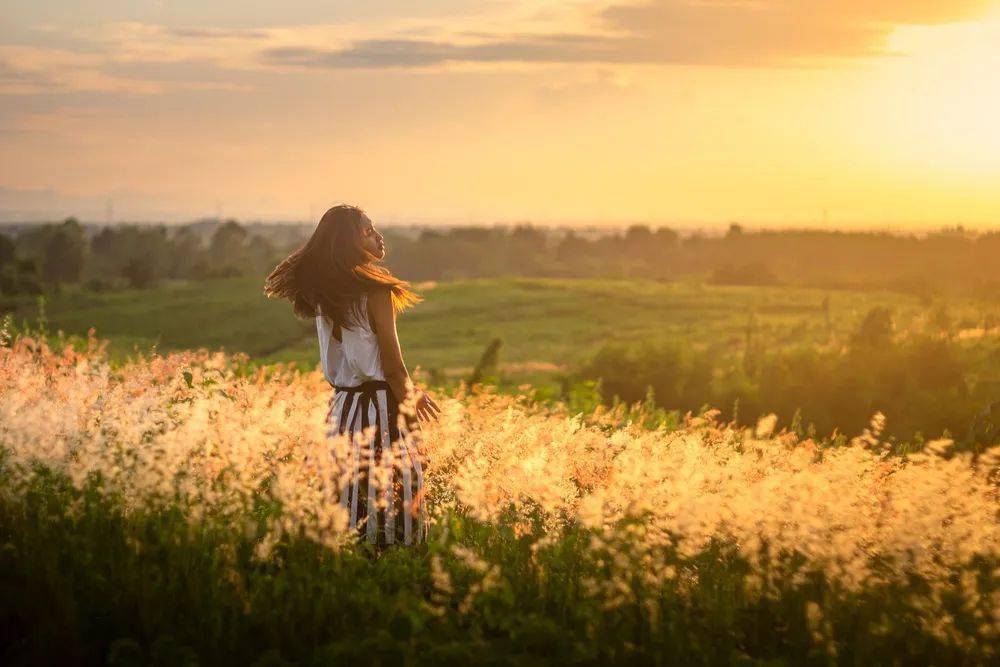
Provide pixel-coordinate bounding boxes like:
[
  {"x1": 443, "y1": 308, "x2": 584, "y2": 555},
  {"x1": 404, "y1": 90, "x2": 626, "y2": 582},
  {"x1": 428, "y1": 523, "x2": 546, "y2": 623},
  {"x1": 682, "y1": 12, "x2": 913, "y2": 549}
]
[{"x1": 0, "y1": 279, "x2": 1000, "y2": 666}]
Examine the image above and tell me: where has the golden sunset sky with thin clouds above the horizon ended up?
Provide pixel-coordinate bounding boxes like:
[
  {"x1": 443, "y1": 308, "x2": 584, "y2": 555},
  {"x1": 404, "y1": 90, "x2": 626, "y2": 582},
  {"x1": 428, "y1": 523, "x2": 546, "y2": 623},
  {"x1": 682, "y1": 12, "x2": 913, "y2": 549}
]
[{"x1": 0, "y1": 0, "x2": 1000, "y2": 229}]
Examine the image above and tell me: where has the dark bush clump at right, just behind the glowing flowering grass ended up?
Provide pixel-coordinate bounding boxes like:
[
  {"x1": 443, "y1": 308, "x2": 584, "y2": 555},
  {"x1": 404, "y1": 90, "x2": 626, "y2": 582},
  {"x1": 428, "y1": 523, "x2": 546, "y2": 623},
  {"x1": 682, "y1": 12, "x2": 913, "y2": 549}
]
[{"x1": 578, "y1": 328, "x2": 1000, "y2": 449}]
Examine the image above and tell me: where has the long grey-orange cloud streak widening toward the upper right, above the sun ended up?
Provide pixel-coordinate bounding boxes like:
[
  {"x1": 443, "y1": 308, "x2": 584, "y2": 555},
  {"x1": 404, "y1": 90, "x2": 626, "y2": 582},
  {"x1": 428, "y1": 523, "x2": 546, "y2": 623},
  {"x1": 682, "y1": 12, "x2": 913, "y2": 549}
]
[{"x1": 261, "y1": 0, "x2": 991, "y2": 68}]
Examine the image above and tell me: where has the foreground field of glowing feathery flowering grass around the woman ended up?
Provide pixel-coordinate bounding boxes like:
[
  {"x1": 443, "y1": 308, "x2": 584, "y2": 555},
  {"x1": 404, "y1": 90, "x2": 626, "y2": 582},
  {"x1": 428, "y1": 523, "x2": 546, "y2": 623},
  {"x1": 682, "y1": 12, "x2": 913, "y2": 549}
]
[{"x1": 0, "y1": 334, "x2": 1000, "y2": 665}]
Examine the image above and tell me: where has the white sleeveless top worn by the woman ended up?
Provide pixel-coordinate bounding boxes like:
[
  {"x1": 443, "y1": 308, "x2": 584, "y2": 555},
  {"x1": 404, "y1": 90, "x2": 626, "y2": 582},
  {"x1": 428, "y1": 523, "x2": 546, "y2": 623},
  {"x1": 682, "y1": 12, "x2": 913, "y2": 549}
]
[{"x1": 316, "y1": 294, "x2": 385, "y2": 387}]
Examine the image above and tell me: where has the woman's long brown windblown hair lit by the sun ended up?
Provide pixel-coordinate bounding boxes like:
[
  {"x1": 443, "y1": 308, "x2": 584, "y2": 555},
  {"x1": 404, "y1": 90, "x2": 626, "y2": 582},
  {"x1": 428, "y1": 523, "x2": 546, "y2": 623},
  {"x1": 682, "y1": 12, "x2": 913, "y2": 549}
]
[{"x1": 264, "y1": 204, "x2": 421, "y2": 329}]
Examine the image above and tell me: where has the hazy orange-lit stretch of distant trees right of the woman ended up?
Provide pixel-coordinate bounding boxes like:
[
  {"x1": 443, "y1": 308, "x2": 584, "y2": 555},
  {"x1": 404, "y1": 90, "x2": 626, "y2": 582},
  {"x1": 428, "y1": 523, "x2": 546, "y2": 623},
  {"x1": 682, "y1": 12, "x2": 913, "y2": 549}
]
[{"x1": 378, "y1": 224, "x2": 1000, "y2": 298}]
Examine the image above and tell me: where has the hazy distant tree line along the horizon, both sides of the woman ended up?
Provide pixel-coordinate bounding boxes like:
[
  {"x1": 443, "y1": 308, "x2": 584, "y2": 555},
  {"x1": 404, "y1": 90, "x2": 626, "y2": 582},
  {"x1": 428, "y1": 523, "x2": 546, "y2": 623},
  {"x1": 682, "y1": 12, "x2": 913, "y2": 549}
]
[{"x1": 0, "y1": 218, "x2": 1000, "y2": 299}]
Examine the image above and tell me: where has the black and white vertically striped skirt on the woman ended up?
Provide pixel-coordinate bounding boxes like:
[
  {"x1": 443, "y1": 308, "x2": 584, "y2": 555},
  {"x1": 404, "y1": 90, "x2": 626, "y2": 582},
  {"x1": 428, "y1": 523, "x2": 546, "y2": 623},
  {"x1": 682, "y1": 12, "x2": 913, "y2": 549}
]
[{"x1": 327, "y1": 380, "x2": 427, "y2": 546}]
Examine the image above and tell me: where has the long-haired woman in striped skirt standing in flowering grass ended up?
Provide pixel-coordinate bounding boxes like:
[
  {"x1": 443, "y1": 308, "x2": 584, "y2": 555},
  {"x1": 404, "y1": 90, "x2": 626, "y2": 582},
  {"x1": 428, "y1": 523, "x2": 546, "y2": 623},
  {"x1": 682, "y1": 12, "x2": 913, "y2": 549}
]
[{"x1": 264, "y1": 205, "x2": 439, "y2": 547}]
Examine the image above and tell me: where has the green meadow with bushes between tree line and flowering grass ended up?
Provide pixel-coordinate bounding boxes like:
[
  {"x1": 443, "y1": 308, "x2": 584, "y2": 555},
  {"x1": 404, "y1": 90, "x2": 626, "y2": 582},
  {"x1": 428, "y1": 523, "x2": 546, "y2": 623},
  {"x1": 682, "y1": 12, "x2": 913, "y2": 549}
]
[{"x1": 0, "y1": 277, "x2": 1000, "y2": 449}]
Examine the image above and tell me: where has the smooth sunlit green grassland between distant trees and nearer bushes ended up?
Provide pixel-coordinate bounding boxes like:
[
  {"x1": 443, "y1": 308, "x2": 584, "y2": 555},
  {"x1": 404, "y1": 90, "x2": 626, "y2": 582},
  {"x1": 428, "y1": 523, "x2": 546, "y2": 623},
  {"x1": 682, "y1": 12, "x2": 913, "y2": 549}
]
[{"x1": 0, "y1": 278, "x2": 984, "y2": 381}]
